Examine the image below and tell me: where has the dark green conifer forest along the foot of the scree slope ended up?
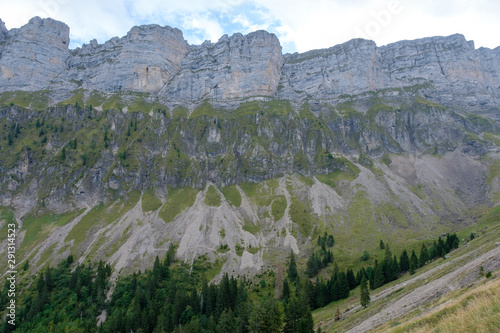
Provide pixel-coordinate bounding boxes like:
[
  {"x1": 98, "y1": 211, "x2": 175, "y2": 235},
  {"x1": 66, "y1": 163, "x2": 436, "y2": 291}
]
[{"x1": 0, "y1": 234, "x2": 459, "y2": 333}]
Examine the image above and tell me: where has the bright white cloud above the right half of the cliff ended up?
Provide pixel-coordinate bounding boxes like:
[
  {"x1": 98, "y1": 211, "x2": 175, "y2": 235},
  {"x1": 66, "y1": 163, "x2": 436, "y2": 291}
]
[{"x1": 255, "y1": 0, "x2": 500, "y2": 52}]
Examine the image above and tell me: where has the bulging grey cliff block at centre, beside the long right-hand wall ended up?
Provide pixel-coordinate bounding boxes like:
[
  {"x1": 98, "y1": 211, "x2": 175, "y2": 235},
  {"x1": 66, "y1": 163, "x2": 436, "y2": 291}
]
[{"x1": 160, "y1": 31, "x2": 283, "y2": 103}]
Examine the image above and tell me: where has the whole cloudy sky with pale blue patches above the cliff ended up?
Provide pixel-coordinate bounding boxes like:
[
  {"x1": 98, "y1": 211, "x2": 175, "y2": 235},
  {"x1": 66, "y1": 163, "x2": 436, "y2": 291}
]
[{"x1": 0, "y1": 0, "x2": 500, "y2": 53}]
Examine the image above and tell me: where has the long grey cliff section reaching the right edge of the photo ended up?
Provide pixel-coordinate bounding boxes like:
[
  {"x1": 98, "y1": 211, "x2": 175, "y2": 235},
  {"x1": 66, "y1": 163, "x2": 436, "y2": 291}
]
[{"x1": 278, "y1": 35, "x2": 500, "y2": 114}]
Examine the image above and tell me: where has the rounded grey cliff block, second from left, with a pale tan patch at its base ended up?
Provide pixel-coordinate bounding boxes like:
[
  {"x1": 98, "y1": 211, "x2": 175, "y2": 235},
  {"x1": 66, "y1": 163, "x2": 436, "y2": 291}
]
[{"x1": 66, "y1": 25, "x2": 189, "y2": 93}]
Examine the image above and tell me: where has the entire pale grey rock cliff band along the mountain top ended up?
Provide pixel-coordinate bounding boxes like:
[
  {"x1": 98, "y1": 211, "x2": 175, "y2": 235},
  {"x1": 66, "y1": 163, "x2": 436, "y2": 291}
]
[{"x1": 0, "y1": 18, "x2": 500, "y2": 120}]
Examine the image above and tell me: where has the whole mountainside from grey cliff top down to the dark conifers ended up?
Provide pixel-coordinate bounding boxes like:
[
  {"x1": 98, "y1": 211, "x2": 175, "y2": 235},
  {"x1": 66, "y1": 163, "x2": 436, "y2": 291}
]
[{"x1": 0, "y1": 18, "x2": 500, "y2": 290}]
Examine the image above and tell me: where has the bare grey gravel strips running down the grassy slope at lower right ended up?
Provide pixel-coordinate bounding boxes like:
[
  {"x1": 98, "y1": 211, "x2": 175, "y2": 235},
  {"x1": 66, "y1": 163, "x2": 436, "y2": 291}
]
[{"x1": 347, "y1": 246, "x2": 500, "y2": 333}]
